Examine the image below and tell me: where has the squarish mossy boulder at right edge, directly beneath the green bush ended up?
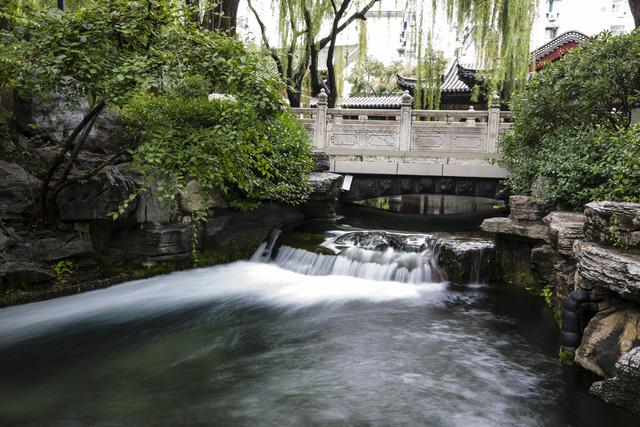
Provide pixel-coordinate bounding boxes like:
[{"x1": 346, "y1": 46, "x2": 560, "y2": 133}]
[{"x1": 584, "y1": 202, "x2": 640, "y2": 249}]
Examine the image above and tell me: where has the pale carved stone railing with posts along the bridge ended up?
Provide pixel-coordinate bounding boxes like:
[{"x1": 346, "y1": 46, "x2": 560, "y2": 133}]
[{"x1": 291, "y1": 90, "x2": 511, "y2": 159}]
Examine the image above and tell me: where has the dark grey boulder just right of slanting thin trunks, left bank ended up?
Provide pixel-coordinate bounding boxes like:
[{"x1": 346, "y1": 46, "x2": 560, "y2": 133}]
[{"x1": 56, "y1": 165, "x2": 136, "y2": 221}]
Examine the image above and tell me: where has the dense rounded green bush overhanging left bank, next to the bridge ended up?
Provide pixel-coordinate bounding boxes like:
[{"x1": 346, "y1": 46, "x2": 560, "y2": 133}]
[{"x1": 123, "y1": 85, "x2": 313, "y2": 208}]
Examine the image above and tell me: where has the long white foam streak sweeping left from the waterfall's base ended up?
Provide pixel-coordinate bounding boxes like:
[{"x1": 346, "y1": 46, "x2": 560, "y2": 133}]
[{"x1": 0, "y1": 262, "x2": 444, "y2": 345}]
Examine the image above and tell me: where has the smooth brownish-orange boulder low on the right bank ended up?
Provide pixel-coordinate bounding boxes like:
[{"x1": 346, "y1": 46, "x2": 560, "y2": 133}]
[{"x1": 575, "y1": 301, "x2": 640, "y2": 378}]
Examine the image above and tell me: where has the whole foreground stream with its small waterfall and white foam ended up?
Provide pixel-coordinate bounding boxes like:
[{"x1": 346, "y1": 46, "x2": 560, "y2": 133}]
[{"x1": 0, "y1": 201, "x2": 638, "y2": 426}]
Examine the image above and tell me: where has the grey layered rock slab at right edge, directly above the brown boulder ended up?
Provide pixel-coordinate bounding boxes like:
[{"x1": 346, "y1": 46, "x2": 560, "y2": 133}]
[{"x1": 577, "y1": 242, "x2": 640, "y2": 302}]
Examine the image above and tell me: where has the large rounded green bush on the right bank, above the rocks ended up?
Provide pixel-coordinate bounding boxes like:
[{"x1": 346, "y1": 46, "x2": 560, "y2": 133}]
[{"x1": 500, "y1": 31, "x2": 640, "y2": 209}]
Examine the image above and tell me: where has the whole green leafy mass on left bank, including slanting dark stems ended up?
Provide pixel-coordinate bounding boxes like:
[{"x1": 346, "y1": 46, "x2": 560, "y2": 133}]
[{"x1": 0, "y1": 0, "x2": 311, "y2": 221}]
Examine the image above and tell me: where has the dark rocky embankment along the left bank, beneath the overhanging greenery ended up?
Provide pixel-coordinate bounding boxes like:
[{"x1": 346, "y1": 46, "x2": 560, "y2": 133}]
[{"x1": 0, "y1": 93, "x2": 342, "y2": 306}]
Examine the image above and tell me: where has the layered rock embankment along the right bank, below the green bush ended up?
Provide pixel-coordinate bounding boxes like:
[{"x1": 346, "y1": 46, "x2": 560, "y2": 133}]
[{"x1": 481, "y1": 196, "x2": 640, "y2": 413}]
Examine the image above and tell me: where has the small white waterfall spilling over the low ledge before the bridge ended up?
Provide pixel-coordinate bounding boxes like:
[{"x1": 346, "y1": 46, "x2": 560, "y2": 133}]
[{"x1": 251, "y1": 243, "x2": 445, "y2": 284}]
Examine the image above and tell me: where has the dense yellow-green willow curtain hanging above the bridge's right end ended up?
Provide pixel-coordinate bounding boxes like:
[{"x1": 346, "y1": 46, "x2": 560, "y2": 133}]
[{"x1": 446, "y1": 0, "x2": 538, "y2": 101}]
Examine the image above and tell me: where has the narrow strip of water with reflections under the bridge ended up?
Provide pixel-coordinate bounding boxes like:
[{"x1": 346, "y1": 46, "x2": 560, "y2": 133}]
[{"x1": 354, "y1": 194, "x2": 505, "y2": 215}]
